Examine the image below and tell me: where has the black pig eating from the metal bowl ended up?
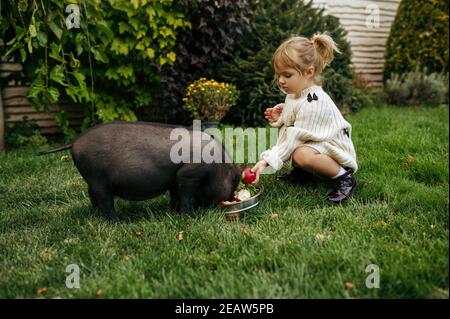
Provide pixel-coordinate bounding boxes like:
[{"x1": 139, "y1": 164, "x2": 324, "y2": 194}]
[{"x1": 39, "y1": 122, "x2": 242, "y2": 221}]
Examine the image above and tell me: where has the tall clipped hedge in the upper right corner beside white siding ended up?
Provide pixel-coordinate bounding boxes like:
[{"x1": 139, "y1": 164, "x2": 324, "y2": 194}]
[{"x1": 384, "y1": 0, "x2": 449, "y2": 81}]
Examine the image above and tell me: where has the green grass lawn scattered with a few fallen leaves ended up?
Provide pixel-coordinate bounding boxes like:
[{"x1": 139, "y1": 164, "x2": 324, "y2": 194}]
[{"x1": 0, "y1": 107, "x2": 449, "y2": 298}]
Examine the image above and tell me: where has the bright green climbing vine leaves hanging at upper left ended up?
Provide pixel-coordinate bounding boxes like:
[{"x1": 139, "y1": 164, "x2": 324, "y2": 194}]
[{"x1": 0, "y1": 0, "x2": 189, "y2": 138}]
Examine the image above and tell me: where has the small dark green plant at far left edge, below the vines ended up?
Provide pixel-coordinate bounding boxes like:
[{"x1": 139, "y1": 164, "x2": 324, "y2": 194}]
[{"x1": 5, "y1": 118, "x2": 47, "y2": 149}]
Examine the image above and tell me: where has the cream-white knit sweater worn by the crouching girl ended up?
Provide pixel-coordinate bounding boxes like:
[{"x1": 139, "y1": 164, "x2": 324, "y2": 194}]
[{"x1": 260, "y1": 85, "x2": 358, "y2": 172}]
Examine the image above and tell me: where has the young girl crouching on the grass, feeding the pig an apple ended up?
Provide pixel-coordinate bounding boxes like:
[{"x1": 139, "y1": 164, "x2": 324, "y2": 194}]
[{"x1": 252, "y1": 34, "x2": 358, "y2": 203}]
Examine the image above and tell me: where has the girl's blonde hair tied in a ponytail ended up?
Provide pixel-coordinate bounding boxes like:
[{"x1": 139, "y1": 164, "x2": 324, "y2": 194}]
[{"x1": 272, "y1": 33, "x2": 341, "y2": 85}]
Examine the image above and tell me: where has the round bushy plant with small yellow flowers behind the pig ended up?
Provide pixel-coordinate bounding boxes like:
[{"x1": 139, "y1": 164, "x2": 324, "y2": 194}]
[{"x1": 183, "y1": 78, "x2": 239, "y2": 130}]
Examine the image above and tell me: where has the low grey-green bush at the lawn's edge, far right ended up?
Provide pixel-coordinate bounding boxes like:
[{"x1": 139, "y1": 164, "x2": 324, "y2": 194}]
[{"x1": 384, "y1": 67, "x2": 449, "y2": 105}]
